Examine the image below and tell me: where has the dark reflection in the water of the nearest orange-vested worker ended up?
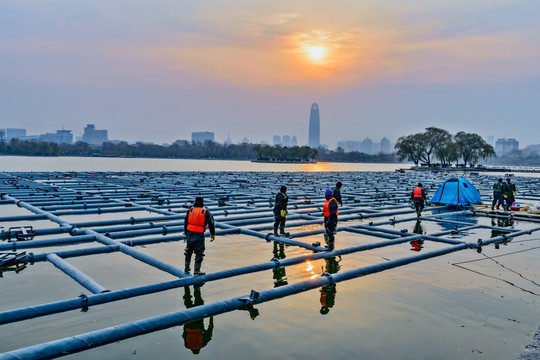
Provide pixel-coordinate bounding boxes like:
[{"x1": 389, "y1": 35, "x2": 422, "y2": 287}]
[{"x1": 182, "y1": 285, "x2": 214, "y2": 354}]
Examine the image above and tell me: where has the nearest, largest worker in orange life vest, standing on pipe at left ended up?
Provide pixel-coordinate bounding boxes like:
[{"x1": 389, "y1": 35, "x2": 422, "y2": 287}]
[{"x1": 184, "y1": 197, "x2": 216, "y2": 275}]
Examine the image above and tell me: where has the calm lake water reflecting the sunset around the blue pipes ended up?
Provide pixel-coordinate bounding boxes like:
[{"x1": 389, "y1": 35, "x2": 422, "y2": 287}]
[{"x1": 0, "y1": 157, "x2": 540, "y2": 360}]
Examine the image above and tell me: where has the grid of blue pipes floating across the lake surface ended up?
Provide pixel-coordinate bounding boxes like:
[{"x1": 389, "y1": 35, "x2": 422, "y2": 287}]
[{"x1": 0, "y1": 172, "x2": 540, "y2": 359}]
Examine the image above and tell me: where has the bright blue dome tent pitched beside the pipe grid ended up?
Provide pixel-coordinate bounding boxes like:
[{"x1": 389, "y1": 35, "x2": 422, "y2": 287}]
[{"x1": 429, "y1": 177, "x2": 482, "y2": 206}]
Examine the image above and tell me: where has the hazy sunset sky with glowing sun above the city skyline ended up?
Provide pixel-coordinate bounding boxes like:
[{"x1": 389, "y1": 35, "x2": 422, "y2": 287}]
[{"x1": 0, "y1": 0, "x2": 540, "y2": 149}]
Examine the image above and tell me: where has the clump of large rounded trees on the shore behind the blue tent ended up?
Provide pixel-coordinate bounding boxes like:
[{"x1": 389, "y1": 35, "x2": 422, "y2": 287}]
[{"x1": 395, "y1": 127, "x2": 495, "y2": 166}]
